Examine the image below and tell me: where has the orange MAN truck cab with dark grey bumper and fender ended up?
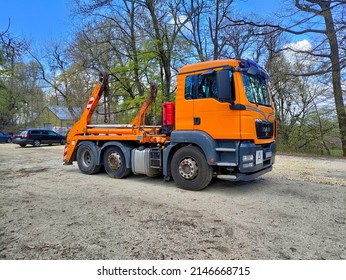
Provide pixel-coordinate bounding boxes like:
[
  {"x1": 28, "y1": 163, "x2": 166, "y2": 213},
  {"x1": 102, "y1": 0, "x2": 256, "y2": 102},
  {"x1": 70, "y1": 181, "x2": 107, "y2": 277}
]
[{"x1": 164, "y1": 60, "x2": 276, "y2": 184}]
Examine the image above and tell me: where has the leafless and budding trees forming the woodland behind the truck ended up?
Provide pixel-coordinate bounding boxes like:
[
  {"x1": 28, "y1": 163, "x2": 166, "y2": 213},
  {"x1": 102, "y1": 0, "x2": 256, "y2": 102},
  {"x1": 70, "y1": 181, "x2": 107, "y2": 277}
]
[{"x1": 0, "y1": 0, "x2": 346, "y2": 156}]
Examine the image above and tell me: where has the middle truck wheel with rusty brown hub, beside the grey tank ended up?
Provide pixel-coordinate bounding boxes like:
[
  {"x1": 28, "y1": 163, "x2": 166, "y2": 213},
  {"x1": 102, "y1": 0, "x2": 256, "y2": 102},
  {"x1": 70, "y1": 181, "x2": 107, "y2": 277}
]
[{"x1": 103, "y1": 146, "x2": 131, "y2": 179}]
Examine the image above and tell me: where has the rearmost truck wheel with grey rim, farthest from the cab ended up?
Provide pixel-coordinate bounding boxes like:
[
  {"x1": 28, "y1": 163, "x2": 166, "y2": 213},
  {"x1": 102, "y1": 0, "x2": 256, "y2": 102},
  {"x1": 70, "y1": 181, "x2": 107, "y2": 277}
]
[{"x1": 77, "y1": 142, "x2": 101, "y2": 175}]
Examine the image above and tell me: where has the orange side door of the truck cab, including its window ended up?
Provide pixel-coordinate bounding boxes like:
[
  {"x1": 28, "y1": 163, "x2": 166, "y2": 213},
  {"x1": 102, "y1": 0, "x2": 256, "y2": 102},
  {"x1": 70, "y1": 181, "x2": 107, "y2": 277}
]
[{"x1": 193, "y1": 70, "x2": 240, "y2": 139}]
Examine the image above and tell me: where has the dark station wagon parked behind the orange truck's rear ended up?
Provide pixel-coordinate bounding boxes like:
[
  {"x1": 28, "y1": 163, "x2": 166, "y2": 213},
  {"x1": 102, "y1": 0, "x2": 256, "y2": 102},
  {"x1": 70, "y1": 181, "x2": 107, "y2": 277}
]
[{"x1": 13, "y1": 128, "x2": 66, "y2": 148}]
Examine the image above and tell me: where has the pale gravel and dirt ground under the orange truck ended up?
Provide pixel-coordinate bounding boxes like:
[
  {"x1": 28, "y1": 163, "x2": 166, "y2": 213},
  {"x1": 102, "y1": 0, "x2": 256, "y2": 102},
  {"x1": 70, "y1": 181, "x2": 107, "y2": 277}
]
[{"x1": 0, "y1": 144, "x2": 346, "y2": 260}]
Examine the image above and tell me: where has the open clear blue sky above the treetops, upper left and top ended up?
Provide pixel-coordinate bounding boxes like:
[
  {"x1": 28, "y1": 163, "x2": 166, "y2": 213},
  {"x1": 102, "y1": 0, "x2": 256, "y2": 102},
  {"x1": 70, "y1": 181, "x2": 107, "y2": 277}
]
[{"x1": 0, "y1": 0, "x2": 279, "y2": 45}]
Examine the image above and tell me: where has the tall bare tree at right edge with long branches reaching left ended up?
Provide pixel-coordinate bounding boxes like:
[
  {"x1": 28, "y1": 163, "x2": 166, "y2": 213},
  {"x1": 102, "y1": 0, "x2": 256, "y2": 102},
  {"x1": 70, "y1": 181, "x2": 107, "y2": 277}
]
[{"x1": 233, "y1": 0, "x2": 346, "y2": 156}]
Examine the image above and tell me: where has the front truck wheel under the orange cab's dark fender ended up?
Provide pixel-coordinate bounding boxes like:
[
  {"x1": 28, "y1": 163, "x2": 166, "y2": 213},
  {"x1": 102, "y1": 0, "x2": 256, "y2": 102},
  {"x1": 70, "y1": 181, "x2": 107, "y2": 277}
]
[{"x1": 171, "y1": 146, "x2": 213, "y2": 191}]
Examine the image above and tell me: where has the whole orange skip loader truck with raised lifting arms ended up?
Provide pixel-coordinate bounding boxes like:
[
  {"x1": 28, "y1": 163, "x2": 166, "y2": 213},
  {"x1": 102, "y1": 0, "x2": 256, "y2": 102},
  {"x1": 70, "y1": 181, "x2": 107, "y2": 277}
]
[{"x1": 64, "y1": 59, "x2": 277, "y2": 190}]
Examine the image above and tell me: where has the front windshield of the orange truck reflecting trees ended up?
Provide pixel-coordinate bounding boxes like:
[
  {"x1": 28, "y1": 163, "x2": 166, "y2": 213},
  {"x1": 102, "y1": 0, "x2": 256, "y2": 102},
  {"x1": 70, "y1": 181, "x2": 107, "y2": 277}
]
[{"x1": 242, "y1": 73, "x2": 271, "y2": 106}]
